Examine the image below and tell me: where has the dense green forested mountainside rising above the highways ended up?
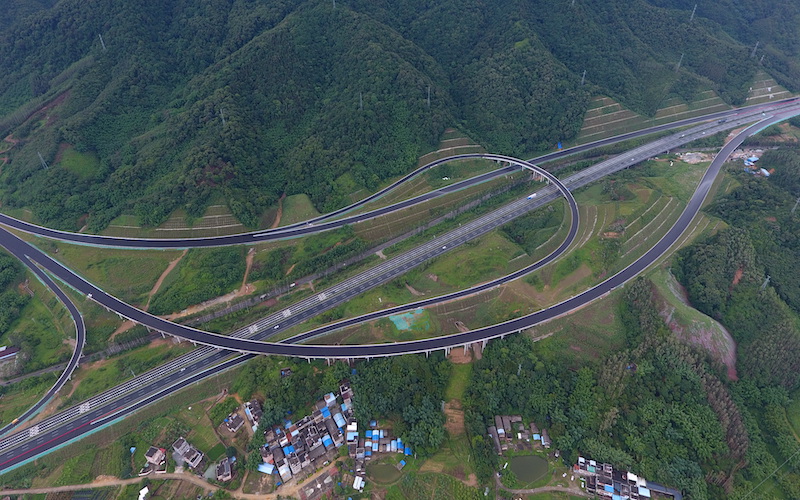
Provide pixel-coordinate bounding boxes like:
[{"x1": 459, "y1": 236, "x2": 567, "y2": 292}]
[{"x1": 0, "y1": 0, "x2": 800, "y2": 230}]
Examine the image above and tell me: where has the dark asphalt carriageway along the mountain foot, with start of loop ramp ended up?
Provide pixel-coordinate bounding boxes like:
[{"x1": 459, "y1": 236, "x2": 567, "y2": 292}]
[{"x1": 0, "y1": 98, "x2": 798, "y2": 248}]
